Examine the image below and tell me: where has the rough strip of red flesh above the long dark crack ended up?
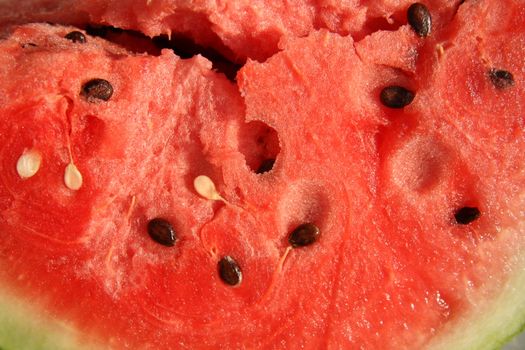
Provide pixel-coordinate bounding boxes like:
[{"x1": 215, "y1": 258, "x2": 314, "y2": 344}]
[{"x1": 0, "y1": 0, "x2": 461, "y2": 62}]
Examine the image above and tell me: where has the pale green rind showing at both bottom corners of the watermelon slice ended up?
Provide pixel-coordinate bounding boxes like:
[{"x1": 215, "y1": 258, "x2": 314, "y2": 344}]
[{"x1": 0, "y1": 239, "x2": 525, "y2": 350}]
